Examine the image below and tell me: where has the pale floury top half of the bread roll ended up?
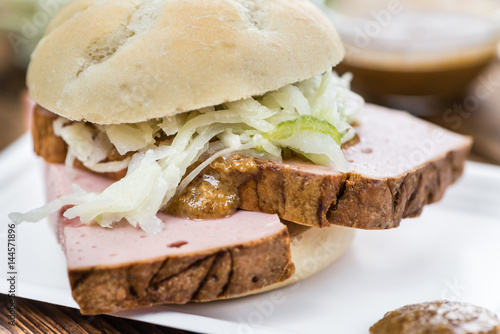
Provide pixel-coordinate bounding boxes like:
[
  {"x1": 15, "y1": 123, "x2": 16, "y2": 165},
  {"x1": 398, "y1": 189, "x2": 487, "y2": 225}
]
[{"x1": 28, "y1": 0, "x2": 344, "y2": 124}]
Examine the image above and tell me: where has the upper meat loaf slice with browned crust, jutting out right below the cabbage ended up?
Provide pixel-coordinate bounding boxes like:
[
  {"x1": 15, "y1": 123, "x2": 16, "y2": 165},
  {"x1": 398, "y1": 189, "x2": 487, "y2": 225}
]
[{"x1": 33, "y1": 105, "x2": 472, "y2": 229}]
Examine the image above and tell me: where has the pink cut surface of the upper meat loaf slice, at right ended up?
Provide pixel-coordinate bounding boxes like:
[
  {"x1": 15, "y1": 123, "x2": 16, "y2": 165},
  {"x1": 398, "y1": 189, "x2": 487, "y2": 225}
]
[{"x1": 288, "y1": 104, "x2": 471, "y2": 179}]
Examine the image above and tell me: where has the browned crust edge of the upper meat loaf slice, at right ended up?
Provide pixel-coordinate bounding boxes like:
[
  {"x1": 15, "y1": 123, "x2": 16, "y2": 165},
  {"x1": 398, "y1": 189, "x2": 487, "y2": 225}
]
[{"x1": 240, "y1": 148, "x2": 469, "y2": 229}]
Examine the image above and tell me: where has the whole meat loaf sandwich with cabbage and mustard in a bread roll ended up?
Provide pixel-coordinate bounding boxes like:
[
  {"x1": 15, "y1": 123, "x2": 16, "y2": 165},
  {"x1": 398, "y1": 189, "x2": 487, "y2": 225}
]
[{"x1": 10, "y1": 0, "x2": 471, "y2": 314}]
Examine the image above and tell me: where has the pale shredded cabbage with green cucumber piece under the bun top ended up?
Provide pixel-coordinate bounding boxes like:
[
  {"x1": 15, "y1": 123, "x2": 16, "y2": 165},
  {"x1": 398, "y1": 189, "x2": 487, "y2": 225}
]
[{"x1": 9, "y1": 72, "x2": 364, "y2": 234}]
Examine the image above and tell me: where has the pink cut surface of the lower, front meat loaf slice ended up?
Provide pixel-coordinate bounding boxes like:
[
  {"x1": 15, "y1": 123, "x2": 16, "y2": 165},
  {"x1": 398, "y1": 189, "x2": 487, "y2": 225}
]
[{"x1": 46, "y1": 165, "x2": 286, "y2": 269}]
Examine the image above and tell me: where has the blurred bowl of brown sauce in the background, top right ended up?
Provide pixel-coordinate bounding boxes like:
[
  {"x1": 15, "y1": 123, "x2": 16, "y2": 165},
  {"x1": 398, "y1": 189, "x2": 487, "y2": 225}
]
[{"x1": 325, "y1": 0, "x2": 500, "y2": 113}]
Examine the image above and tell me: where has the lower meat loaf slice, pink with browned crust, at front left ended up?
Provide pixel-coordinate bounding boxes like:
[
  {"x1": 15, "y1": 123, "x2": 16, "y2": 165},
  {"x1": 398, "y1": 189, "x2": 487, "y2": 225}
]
[{"x1": 46, "y1": 164, "x2": 294, "y2": 314}]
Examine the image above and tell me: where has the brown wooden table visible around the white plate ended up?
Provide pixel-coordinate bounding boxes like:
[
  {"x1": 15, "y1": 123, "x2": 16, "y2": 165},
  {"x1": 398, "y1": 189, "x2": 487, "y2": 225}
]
[{"x1": 0, "y1": 63, "x2": 500, "y2": 333}]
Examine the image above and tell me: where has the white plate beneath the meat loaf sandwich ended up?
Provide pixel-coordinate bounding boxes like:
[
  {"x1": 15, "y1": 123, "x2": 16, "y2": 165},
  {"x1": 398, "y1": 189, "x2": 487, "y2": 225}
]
[{"x1": 0, "y1": 136, "x2": 500, "y2": 334}]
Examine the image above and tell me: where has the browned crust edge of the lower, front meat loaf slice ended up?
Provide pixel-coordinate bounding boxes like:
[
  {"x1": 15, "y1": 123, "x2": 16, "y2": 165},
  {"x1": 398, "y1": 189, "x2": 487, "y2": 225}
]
[{"x1": 68, "y1": 229, "x2": 295, "y2": 314}]
